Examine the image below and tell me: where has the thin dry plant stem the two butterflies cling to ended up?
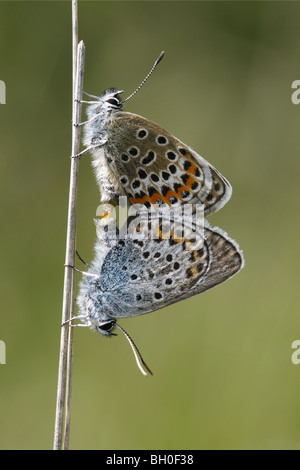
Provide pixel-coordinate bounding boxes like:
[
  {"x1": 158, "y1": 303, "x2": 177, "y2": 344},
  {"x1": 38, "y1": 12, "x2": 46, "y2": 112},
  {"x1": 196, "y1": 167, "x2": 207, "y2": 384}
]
[{"x1": 53, "y1": 0, "x2": 85, "y2": 450}]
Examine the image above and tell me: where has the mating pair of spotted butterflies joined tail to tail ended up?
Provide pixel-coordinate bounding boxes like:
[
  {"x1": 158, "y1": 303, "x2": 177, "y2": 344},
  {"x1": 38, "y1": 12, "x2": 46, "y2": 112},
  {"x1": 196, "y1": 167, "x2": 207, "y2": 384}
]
[{"x1": 75, "y1": 51, "x2": 244, "y2": 375}]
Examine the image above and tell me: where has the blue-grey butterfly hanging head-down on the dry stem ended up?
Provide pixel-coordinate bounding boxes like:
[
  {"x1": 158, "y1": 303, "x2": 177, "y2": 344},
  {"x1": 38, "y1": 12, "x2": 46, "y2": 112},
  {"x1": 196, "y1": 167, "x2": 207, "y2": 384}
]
[{"x1": 69, "y1": 211, "x2": 244, "y2": 375}]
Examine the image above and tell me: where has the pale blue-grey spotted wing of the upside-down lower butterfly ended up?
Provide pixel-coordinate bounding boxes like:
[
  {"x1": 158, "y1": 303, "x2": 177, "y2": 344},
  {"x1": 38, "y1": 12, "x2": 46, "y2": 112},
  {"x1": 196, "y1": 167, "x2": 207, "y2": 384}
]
[{"x1": 93, "y1": 210, "x2": 243, "y2": 318}]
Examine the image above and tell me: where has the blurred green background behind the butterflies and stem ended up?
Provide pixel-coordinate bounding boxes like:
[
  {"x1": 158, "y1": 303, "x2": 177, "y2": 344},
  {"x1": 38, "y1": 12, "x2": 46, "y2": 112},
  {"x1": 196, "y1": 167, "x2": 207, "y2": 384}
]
[{"x1": 0, "y1": 1, "x2": 300, "y2": 450}]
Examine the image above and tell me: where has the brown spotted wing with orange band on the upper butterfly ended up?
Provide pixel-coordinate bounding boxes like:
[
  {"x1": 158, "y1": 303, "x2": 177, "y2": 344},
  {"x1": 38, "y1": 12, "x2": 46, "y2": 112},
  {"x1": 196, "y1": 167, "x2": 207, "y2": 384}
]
[{"x1": 104, "y1": 112, "x2": 232, "y2": 215}]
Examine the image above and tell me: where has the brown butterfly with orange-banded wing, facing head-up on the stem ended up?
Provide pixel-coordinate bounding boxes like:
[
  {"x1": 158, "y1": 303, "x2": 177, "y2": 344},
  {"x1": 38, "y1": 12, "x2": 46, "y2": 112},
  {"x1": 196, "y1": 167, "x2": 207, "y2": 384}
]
[{"x1": 82, "y1": 53, "x2": 232, "y2": 215}]
